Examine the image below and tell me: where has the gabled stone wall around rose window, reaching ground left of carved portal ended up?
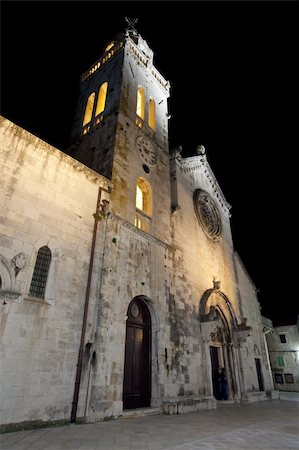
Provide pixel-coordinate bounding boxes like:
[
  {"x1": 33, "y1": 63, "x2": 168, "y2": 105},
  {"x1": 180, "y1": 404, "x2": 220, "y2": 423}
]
[{"x1": 165, "y1": 157, "x2": 235, "y2": 396}]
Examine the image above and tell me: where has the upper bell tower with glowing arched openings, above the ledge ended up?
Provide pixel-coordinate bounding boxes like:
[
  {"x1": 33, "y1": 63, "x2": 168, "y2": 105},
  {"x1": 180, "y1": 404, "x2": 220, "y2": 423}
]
[{"x1": 71, "y1": 27, "x2": 171, "y2": 235}]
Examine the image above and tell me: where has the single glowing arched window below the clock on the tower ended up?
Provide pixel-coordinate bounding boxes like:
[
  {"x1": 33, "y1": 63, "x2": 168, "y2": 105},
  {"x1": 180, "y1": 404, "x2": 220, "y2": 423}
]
[{"x1": 135, "y1": 177, "x2": 153, "y2": 231}]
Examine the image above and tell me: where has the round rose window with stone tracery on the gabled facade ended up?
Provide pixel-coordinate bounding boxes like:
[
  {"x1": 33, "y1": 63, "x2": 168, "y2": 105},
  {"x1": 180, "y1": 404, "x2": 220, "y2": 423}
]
[{"x1": 193, "y1": 189, "x2": 222, "y2": 239}]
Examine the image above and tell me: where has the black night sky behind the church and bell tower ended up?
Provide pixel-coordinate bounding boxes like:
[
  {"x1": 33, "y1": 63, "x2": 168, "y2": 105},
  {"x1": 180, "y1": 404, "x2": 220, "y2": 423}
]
[{"x1": 1, "y1": 1, "x2": 299, "y2": 325}]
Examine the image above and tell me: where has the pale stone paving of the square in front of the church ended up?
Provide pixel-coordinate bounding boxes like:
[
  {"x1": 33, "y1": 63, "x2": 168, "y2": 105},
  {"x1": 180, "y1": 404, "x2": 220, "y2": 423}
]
[{"x1": 0, "y1": 400, "x2": 299, "y2": 450}]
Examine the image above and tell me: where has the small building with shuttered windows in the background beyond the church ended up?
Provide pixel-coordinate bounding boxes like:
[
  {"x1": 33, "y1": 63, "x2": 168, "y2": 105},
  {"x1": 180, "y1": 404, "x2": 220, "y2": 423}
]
[{"x1": 264, "y1": 317, "x2": 299, "y2": 392}]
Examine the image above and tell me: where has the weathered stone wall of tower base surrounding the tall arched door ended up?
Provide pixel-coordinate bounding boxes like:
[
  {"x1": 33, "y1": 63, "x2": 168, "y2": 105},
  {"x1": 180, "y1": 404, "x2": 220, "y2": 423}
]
[{"x1": 81, "y1": 215, "x2": 176, "y2": 419}]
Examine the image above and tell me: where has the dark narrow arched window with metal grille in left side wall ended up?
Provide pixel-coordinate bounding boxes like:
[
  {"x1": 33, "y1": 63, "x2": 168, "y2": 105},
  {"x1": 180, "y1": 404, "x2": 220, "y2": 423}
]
[{"x1": 29, "y1": 246, "x2": 51, "y2": 298}]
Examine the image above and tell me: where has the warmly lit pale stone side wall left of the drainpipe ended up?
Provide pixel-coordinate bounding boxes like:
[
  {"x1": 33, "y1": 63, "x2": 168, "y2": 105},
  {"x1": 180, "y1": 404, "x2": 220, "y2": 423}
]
[{"x1": 0, "y1": 118, "x2": 111, "y2": 424}]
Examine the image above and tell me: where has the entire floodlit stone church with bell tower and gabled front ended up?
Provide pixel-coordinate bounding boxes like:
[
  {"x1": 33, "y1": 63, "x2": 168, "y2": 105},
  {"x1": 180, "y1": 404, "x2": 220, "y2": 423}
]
[{"x1": 0, "y1": 31, "x2": 276, "y2": 429}]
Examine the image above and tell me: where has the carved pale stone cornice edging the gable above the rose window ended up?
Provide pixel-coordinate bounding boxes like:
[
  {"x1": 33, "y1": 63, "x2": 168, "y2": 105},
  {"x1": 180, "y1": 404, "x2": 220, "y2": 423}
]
[{"x1": 175, "y1": 153, "x2": 231, "y2": 217}]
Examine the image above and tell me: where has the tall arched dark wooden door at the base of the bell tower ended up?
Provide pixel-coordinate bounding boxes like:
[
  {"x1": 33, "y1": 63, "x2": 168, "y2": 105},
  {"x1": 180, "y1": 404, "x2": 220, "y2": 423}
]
[{"x1": 123, "y1": 298, "x2": 151, "y2": 409}]
